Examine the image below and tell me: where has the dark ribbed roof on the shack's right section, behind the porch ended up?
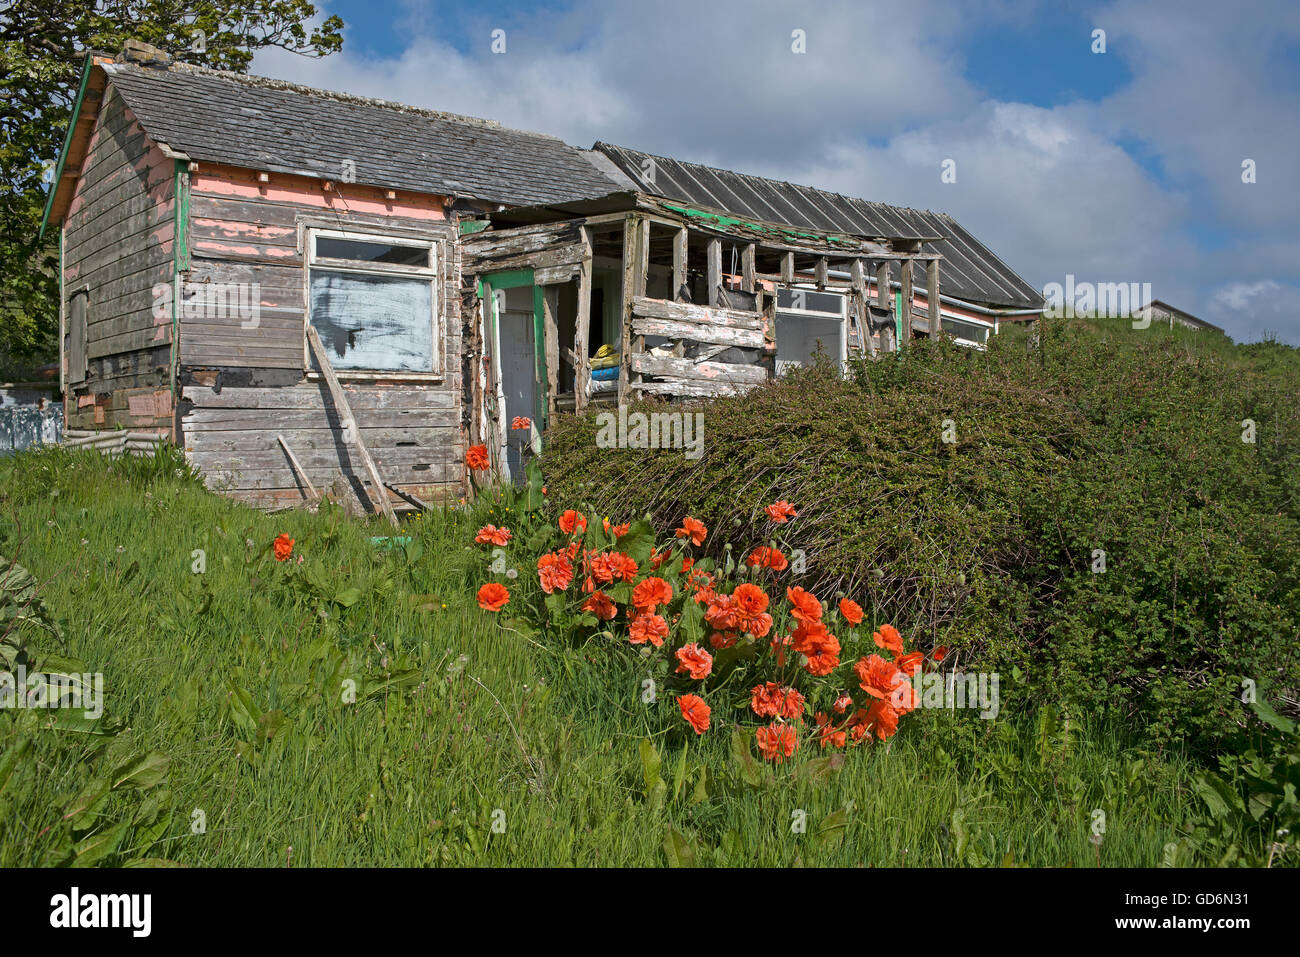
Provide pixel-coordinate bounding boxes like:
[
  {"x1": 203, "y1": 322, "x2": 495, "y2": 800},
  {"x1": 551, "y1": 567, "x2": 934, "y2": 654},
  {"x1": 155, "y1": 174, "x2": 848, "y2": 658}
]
[{"x1": 593, "y1": 143, "x2": 1043, "y2": 308}]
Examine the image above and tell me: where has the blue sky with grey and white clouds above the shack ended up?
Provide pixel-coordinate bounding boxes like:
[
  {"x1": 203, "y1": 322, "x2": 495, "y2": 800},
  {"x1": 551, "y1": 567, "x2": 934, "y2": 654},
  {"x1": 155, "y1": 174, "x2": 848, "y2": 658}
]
[{"x1": 245, "y1": 0, "x2": 1300, "y2": 346}]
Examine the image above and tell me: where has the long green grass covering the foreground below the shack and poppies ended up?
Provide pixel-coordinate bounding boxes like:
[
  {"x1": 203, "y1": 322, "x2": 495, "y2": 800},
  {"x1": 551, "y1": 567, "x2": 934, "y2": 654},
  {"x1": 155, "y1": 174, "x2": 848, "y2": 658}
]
[{"x1": 0, "y1": 450, "x2": 1195, "y2": 867}]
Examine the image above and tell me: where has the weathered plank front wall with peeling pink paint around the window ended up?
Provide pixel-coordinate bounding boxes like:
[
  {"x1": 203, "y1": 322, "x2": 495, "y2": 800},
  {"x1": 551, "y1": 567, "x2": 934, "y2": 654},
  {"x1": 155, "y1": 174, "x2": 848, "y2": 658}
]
[{"x1": 181, "y1": 165, "x2": 465, "y2": 507}]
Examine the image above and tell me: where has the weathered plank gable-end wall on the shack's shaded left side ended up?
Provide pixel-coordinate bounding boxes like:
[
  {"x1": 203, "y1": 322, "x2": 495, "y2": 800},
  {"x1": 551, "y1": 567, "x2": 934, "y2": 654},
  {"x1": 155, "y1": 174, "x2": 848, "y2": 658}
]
[{"x1": 64, "y1": 88, "x2": 176, "y2": 429}]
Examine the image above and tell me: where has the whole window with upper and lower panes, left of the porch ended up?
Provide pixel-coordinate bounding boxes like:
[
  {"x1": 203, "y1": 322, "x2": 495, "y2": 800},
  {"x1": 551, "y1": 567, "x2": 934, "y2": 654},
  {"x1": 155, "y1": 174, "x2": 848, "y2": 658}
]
[{"x1": 307, "y1": 229, "x2": 442, "y2": 376}]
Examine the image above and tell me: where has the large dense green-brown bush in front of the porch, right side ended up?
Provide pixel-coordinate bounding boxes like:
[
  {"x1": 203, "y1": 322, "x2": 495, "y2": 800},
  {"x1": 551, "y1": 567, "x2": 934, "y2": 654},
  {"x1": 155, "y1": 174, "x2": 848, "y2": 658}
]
[{"x1": 542, "y1": 320, "x2": 1300, "y2": 753}]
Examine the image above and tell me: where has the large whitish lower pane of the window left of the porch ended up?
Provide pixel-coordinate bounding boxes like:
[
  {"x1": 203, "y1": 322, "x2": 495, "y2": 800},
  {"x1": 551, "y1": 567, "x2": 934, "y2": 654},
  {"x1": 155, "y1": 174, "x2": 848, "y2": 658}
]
[{"x1": 311, "y1": 270, "x2": 433, "y2": 372}]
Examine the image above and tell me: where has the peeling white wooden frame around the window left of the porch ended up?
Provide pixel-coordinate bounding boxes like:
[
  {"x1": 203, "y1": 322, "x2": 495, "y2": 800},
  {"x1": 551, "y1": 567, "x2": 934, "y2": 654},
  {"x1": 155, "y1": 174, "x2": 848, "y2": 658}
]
[{"x1": 302, "y1": 222, "x2": 446, "y2": 382}]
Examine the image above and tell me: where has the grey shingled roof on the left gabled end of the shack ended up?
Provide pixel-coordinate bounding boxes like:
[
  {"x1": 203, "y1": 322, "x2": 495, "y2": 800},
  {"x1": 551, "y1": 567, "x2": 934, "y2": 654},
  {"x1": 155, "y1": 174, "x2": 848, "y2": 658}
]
[{"x1": 104, "y1": 62, "x2": 618, "y2": 205}]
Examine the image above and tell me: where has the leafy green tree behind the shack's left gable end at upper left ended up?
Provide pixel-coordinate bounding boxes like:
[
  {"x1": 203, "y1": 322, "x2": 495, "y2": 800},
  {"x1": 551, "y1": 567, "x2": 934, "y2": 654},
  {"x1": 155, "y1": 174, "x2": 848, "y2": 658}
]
[{"x1": 0, "y1": 0, "x2": 343, "y2": 371}]
